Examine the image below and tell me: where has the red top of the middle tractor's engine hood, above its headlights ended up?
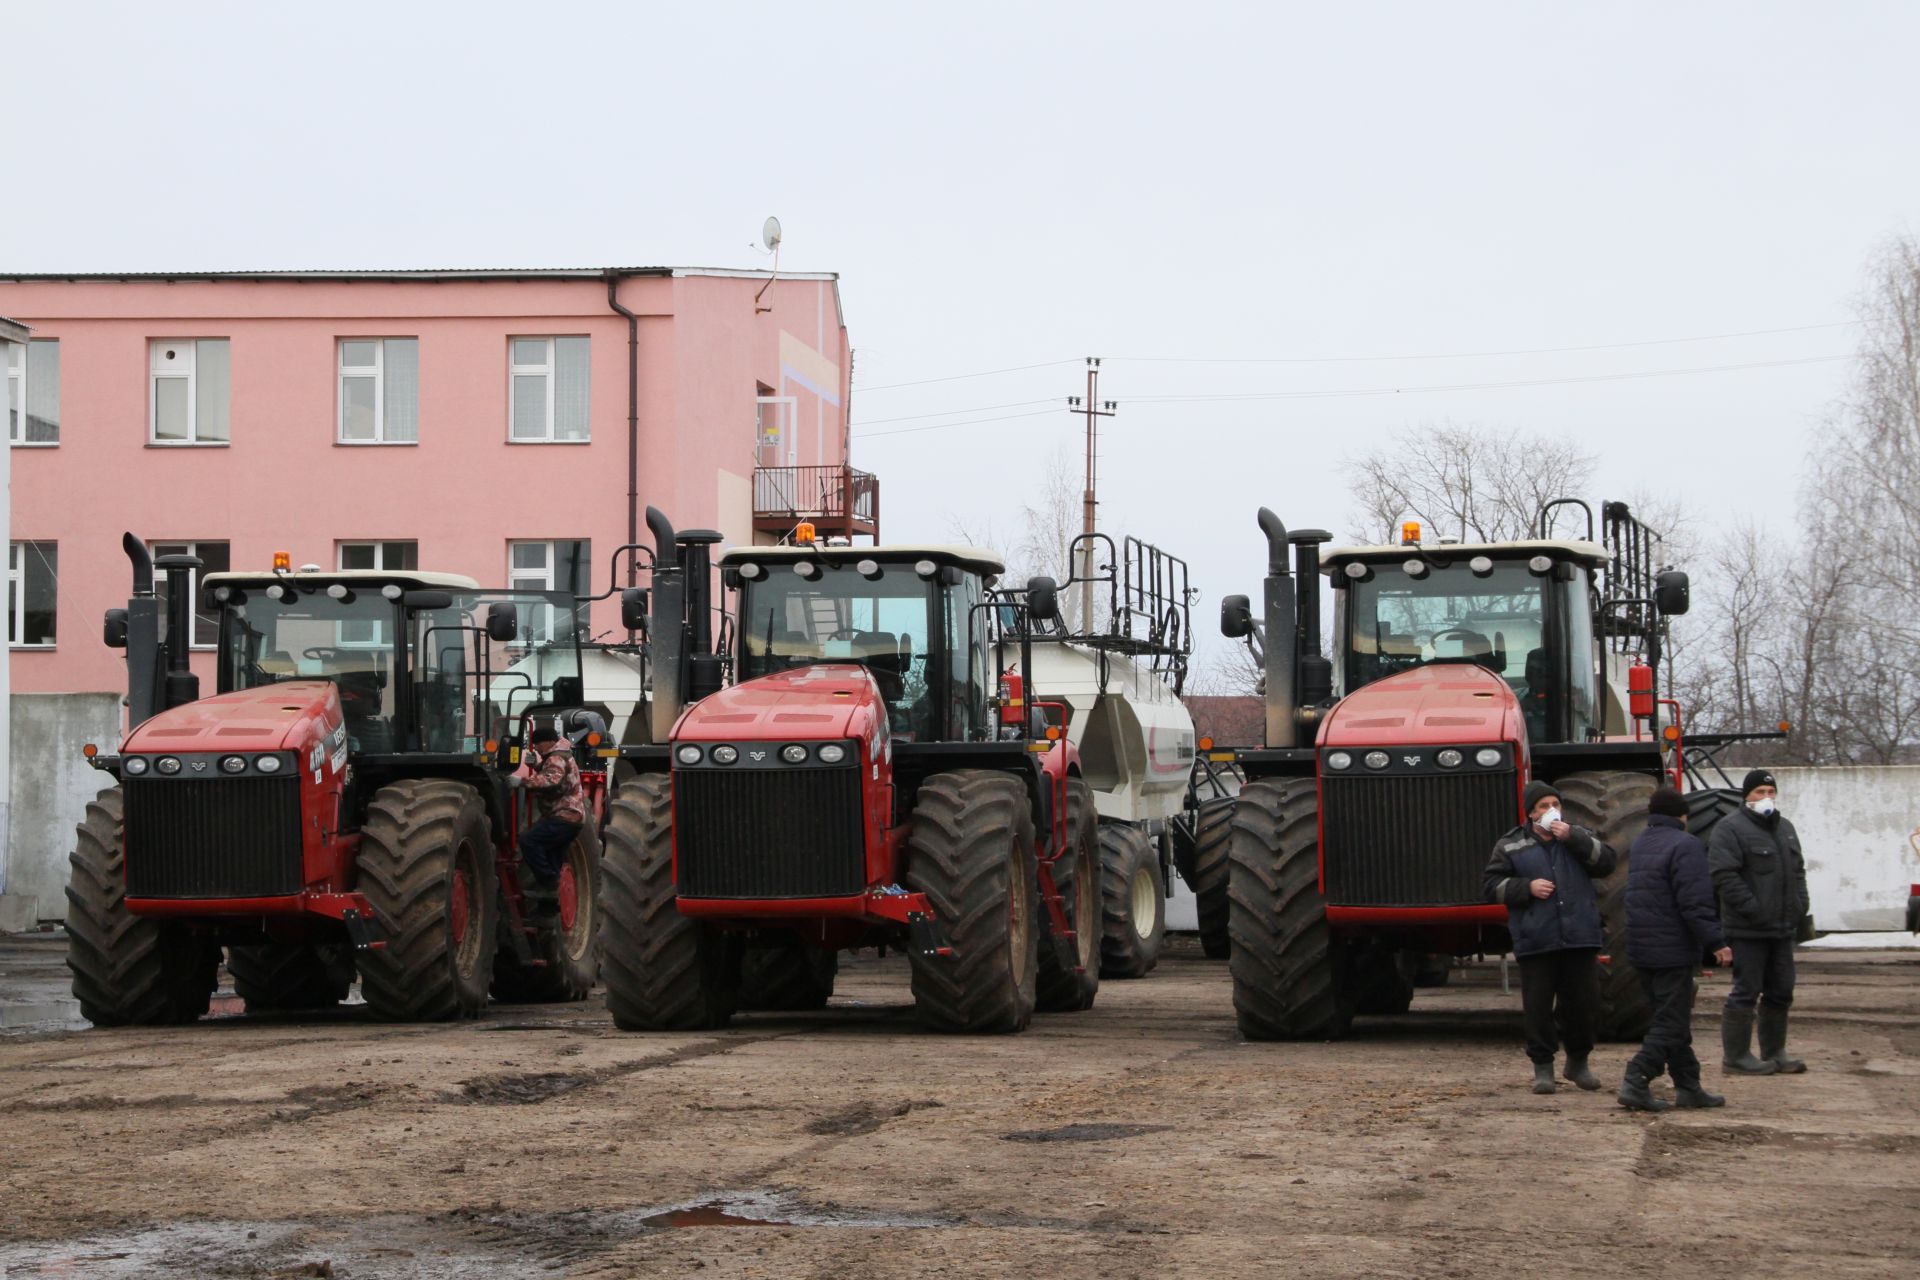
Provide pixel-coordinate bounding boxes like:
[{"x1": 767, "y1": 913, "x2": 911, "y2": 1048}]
[{"x1": 674, "y1": 662, "x2": 887, "y2": 743}]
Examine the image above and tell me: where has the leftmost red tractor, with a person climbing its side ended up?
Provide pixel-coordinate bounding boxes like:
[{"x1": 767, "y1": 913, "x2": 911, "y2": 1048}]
[{"x1": 67, "y1": 533, "x2": 607, "y2": 1027}]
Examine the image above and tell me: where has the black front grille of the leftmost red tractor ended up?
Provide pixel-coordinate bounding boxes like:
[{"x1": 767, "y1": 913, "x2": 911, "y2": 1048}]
[{"x1": 123, "y1": 777, "x2": 305, "y2": 898}]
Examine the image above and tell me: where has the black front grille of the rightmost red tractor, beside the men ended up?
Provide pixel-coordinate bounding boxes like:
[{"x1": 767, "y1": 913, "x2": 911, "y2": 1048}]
[{"x1": 1321, "y1": 770, "x2": 1519, "y2": 906}]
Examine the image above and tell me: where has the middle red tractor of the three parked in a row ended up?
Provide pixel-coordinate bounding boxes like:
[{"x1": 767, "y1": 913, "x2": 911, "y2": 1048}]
[{"x1": 601, "y1": 510, "x2": 1100, "y2": 1032}]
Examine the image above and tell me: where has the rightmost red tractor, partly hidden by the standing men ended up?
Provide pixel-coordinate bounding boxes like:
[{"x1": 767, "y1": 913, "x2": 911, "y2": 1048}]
[{"x1": 1200, "y1": 499, "x2": 1759, "y2": 1040}]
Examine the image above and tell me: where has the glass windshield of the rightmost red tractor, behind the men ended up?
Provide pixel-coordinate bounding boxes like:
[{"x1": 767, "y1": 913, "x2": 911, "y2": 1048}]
[{"x1": 1344, "y1": 560, "x2": 1551, "y2": 721}]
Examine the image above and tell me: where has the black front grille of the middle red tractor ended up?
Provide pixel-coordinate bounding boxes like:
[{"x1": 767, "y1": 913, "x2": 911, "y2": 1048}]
[{"x1": 674, "y1": 768, "x2": 866, "y2": 898}]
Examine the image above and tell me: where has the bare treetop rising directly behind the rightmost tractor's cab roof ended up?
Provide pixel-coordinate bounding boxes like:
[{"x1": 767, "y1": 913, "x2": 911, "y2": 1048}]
[{"x1": 1346, "y1": 422, "x2": 1594, "y2": 543}]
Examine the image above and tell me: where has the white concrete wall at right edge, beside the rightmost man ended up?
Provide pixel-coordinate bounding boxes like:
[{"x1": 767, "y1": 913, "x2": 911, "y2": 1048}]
[{"x1": 1774, "y1": 766, "x2": 1920, "y2": 933}]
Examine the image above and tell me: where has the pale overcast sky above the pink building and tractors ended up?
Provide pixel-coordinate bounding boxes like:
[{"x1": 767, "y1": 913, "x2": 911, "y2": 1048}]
[{"x1": 0, "y1": 2, "x2": 1920, "y2": 671}]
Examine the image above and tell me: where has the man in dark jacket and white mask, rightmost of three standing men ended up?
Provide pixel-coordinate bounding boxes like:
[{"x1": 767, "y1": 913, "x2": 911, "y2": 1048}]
[{"x1": 1707, "y1": 770, "x2": 1809, "y2": 1075}]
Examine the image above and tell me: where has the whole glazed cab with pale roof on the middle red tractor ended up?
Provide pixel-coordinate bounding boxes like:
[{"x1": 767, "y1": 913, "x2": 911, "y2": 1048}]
[{"x1": 720, "y1": 545, "x2": 1006, "y2": 743}]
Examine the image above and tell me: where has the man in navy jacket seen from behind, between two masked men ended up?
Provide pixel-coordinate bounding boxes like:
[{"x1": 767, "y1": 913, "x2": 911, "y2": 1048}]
[{"x1": 1619, "y1": 787, "x2": 1734, "y2": 1111}]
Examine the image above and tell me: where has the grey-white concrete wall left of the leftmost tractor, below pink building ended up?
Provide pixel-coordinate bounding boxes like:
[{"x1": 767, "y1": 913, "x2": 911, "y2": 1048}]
[{"x1": 0, "y1": 693, "x2": 121, "y2": 929}]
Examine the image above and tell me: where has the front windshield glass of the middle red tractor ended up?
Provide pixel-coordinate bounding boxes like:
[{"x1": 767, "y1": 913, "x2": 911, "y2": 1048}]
[{"x1": 739, "y1": 560, "x2": 941, "y2": 741}]
